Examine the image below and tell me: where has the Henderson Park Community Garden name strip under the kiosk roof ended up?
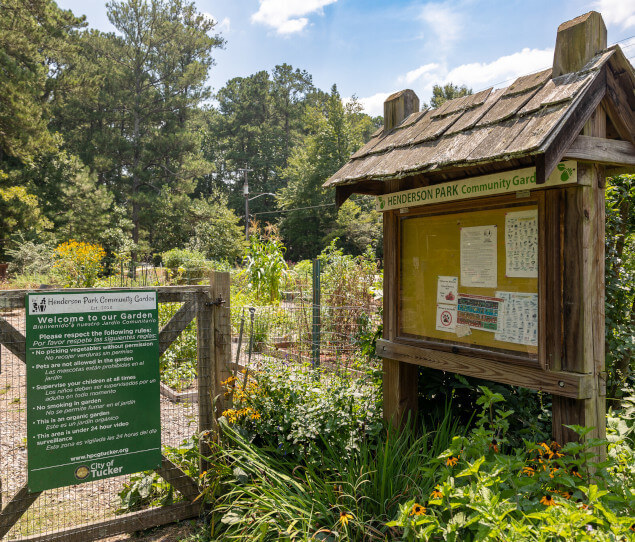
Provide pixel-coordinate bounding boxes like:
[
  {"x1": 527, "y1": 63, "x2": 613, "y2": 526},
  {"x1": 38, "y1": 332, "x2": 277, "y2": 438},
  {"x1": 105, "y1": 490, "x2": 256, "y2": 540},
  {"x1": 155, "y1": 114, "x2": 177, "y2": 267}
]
[{"x1": 376, "y1": 160, "x2": 578, "y2": 211}]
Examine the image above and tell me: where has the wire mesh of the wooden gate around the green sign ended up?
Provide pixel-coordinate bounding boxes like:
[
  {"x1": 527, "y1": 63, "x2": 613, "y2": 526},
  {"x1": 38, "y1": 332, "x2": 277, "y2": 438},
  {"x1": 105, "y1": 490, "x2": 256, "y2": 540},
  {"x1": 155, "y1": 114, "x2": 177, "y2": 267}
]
[{"x1": 0, "y1": 286, "x2": 204, "y2": 540}]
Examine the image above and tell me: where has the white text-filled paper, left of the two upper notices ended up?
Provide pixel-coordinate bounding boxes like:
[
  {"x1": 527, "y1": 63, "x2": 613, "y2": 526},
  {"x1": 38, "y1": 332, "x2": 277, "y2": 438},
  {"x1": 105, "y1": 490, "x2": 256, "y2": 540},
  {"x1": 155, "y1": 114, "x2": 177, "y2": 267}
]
[{"x1": 461, "y1": 226, "x2": 497, "y2": 288}]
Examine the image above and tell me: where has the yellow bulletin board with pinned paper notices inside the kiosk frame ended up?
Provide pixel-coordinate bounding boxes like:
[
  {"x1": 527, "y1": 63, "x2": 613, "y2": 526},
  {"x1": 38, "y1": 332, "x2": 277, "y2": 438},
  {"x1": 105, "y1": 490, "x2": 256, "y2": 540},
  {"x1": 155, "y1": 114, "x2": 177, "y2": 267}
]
[{"x1": 398, "y1": 202, "x2": 540, "y2": 358}]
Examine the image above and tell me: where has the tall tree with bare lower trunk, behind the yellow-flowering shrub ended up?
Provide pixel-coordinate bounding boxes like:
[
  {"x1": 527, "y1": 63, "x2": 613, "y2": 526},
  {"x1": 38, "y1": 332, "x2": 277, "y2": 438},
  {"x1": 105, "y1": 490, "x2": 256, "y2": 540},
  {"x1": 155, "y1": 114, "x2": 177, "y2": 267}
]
[{"x1": 54, "y1": 0, "x2": 223, "y2": 251}]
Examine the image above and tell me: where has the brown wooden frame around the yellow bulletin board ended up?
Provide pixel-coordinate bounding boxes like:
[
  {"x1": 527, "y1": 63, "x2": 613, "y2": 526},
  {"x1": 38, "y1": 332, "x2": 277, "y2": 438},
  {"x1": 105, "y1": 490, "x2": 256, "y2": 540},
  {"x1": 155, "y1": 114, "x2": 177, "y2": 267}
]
[{"x1": 384, "y1": 191, "x2": 549, "y2": 369}]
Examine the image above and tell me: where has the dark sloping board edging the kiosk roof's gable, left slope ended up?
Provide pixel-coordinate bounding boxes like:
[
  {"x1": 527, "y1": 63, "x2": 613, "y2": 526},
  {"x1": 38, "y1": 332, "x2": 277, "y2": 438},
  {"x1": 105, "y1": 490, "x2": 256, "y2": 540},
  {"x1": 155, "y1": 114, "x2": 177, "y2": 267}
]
[{"x1": 536, "y1": 66, "x2": 608, "y2": 184}]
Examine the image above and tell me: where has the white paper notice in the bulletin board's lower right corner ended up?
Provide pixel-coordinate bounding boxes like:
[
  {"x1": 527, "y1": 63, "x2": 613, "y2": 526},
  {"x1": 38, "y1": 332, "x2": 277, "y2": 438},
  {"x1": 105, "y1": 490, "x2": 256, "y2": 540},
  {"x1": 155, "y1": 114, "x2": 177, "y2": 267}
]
[{"x1": 494, "y1": 292, "x2": 538, "y2": 346}]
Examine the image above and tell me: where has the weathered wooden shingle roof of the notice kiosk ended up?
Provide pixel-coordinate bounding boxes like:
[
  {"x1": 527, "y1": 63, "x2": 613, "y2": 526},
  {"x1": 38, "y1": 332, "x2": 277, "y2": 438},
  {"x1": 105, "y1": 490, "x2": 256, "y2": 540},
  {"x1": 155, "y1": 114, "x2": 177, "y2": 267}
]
[{"x1": 324, "y1": 46, "x2": 635, "y2": 198}]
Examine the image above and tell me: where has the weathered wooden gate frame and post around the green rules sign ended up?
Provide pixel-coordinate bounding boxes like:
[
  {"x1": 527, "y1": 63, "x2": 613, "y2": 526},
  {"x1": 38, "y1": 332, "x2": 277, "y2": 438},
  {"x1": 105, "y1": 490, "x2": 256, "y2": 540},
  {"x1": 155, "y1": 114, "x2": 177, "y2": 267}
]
[{"x1": 0, "y1": 280, "x2": 231, "y2": 542}]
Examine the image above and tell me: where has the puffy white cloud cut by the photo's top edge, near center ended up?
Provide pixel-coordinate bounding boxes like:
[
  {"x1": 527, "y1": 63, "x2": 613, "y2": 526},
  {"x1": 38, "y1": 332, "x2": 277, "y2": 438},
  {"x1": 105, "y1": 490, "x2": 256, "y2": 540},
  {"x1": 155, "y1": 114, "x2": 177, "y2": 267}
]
[{"x1": 251, "y1": 0, "x2": 337, "y2": 35}]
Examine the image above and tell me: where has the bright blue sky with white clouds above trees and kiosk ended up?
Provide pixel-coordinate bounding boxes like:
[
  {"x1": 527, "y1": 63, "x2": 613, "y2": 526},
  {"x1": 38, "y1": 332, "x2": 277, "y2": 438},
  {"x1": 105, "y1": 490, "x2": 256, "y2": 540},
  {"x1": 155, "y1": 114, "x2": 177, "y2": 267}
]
[{"x1": 57, "y1": 0, "x2": 635, "y2": 115}]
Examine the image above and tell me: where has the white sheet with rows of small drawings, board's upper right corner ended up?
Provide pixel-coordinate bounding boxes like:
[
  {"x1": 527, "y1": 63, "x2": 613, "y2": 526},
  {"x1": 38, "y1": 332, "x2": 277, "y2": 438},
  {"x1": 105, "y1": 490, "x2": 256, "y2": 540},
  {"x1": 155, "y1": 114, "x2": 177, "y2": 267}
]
[{"x1": 505, "y1": 209, "x2": 538, "y2": 278}]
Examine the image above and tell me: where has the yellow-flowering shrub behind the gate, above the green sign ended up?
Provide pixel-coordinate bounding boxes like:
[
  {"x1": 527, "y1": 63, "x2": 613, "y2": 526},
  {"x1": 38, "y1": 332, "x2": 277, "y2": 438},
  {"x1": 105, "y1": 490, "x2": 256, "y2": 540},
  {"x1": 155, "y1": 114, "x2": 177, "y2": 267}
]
[{"x1": 53, "y1": 239, "x2": 106, "y2": 288}]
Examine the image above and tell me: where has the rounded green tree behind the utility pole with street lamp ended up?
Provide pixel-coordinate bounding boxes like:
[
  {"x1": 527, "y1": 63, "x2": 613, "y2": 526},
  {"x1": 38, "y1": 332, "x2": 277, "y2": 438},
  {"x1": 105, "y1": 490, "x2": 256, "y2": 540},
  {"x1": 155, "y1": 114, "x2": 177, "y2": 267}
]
[{"x1": 197, "y1": 64, "x2": 316, "y2": 222}]
